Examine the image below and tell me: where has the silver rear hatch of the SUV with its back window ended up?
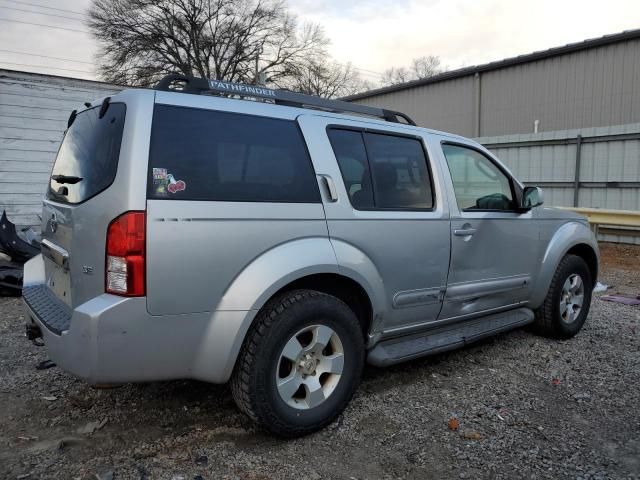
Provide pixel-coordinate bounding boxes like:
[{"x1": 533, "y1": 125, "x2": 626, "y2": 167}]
[{"x1": 42, "y1": 103, "x2": 126, "y2": 308}]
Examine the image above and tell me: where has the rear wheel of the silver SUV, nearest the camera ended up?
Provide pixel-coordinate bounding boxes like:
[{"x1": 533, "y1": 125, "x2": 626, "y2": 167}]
[{"x1": 231, "y1": 290, "x2": 364, "y2": 437}]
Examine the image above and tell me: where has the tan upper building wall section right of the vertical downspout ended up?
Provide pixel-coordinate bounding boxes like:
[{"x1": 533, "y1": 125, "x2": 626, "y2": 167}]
[{"x1": 480, "y1": 40, "x2": 640, "y2": 135}]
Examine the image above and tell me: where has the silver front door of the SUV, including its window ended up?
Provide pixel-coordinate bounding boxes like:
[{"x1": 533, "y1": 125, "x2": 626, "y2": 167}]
[{"x1": 440, "y1": 141, "x2": 540, "y2": 319}]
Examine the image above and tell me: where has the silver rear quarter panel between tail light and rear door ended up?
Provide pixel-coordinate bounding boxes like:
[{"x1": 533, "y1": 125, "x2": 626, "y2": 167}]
[{"x1": 147, "y1": 200, "x2": 327, "y2": 315}]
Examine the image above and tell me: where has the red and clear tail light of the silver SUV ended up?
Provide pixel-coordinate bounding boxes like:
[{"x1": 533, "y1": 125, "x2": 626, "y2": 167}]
[{"x1": 105, "y1": 212, "x2": 146, "y2": 297}]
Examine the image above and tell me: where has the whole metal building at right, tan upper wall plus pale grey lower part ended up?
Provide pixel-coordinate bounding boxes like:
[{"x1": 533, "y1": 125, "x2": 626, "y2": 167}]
[{"x1": 346, "y1": 29, "x2": 640, "y2": 243}]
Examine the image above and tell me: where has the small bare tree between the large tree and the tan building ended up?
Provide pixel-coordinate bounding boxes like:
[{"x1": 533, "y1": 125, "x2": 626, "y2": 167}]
[{"x1": 276, "y1": 56, "x2": 368, "y2": 98}]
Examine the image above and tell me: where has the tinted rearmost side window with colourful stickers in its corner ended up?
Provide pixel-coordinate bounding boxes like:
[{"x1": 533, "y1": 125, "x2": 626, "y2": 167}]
[{"x1": 147, "y1": 105, "x2": 320, "y2": 203}]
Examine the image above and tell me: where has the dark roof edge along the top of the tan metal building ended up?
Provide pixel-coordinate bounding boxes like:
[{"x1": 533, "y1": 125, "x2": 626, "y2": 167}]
[{"x1": 341, "y1": 29, "x2": 640, "y2": 102}]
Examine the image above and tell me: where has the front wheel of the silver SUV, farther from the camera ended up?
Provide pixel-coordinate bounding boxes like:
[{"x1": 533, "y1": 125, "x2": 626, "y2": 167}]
[{"x1": 533, "y1": 255, "x2": 593, "y2": 338}]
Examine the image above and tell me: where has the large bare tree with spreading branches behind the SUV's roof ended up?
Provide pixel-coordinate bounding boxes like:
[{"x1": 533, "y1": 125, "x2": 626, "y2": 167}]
[{"x1": 89, "y1": 0, "x2": 328, "y2": 85}]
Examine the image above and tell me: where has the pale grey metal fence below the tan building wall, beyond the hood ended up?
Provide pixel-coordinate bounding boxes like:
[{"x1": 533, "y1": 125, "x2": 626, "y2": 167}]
[{"x1": 476, "y1": 123, "x2": 640, "y2": 244}]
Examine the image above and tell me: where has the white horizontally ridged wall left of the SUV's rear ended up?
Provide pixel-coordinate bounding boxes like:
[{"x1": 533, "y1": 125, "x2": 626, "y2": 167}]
[{"x1": 0, "y1": 70, "x2": 118, "y2": 225}]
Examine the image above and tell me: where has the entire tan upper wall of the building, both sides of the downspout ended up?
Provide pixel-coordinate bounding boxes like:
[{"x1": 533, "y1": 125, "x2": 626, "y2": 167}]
[{"x1": 354, "y1": 35, "x2": 640, "y2": 137}]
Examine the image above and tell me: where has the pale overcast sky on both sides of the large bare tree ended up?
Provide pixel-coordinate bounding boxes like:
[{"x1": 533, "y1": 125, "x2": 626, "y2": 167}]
[{"x1": 0, "y1": 0, "x2": 640, "y2": 81}]
